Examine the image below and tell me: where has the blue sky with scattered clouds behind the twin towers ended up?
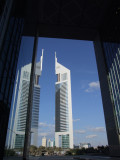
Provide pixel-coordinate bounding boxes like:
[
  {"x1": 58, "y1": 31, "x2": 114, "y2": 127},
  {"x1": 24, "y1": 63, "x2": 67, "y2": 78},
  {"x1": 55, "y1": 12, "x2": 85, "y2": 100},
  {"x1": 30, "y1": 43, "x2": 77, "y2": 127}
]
[{"x1": 15, "y1": 37, "x2": 107, "y2": 146}]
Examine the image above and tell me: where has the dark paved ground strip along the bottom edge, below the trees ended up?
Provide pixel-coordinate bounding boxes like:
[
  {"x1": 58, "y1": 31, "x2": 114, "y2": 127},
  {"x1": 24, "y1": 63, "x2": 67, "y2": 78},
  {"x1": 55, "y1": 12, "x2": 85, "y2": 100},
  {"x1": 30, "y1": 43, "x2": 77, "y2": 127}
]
[{"x1": 4, "y1": 155, "x2": 120, "y2": 160}]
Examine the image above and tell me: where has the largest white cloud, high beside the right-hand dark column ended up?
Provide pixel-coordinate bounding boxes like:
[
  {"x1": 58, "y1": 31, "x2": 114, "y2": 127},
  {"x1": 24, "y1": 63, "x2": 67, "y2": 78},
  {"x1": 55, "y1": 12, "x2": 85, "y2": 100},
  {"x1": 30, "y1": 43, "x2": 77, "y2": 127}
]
[{"x1": 85, "y1": 81, "x2": 100, "y2": 92}]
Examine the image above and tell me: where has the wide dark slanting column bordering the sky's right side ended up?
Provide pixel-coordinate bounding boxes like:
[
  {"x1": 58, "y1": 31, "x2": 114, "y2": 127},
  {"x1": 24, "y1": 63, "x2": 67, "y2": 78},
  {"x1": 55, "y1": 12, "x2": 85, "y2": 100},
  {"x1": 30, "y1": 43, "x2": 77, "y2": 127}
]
[{"x1": 94, "y1": 36, "x2": 120, "y2": 156}]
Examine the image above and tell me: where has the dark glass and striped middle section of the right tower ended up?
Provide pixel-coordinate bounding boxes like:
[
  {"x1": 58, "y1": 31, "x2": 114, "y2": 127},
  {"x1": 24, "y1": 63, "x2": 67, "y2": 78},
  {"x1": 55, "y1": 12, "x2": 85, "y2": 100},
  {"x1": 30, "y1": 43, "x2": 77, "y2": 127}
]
[{"x1": 55, "y1": 82, "x2": 69, "y2": 132}]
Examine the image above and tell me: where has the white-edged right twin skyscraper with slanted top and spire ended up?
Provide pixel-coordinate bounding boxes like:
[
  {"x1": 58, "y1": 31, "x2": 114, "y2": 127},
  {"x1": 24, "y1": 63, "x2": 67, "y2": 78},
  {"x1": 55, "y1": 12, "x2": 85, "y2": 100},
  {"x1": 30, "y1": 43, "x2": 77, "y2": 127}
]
[{"x1": 55, "y1": 53, "x2": 73, "y2": 148}]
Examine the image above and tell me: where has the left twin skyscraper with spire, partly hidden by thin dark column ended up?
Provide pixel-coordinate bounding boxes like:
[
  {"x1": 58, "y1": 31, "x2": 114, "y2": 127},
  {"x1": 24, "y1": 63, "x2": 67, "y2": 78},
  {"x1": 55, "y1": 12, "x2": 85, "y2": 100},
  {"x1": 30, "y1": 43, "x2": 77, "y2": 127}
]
[{"x1": 8, "y1": 51, "x2": 43, "y2": 148}]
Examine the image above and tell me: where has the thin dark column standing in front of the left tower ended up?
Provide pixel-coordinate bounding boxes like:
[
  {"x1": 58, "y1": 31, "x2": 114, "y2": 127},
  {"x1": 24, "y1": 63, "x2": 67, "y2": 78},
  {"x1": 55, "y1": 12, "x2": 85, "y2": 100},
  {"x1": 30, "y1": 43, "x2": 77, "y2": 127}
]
[{"x1": 23, "y1": 31, "x2": 38, "y2": 160}]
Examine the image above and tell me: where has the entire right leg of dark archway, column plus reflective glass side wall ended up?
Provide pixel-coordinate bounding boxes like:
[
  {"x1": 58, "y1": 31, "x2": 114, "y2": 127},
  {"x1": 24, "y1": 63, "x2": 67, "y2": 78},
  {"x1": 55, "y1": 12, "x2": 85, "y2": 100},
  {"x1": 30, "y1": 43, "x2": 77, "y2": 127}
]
[{"x1": 94, "y1": 36, "x2": 120, "y2": 156}]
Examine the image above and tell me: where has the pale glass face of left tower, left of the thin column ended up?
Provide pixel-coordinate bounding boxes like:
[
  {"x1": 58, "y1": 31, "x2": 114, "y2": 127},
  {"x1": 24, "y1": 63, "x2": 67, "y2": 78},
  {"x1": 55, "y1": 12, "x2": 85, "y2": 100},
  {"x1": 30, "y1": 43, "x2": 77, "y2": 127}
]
[{"x1": 10, "y1": 64, "x2": 31, "y2": 148}]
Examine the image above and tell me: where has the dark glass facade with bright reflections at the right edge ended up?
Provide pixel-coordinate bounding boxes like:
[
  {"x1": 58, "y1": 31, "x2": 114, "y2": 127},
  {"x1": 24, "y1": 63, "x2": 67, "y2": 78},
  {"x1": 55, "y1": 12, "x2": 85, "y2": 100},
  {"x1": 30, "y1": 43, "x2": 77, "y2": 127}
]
[{"x1": 103, "y1": 42, "x2": 120, "y2": 134}]
